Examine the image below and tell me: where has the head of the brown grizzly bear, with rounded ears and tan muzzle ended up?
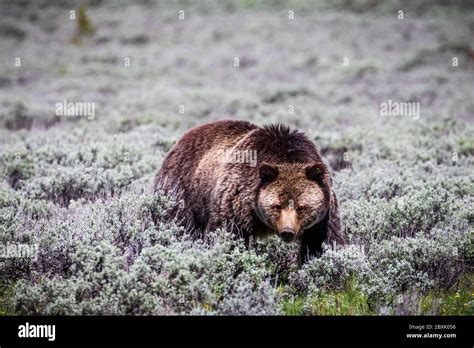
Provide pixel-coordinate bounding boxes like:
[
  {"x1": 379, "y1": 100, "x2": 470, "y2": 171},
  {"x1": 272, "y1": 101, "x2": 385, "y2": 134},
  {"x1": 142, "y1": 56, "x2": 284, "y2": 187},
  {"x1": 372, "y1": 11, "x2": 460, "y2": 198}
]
[{"x1": 256, "y1": 163, "x2": 331, "y2": 242}]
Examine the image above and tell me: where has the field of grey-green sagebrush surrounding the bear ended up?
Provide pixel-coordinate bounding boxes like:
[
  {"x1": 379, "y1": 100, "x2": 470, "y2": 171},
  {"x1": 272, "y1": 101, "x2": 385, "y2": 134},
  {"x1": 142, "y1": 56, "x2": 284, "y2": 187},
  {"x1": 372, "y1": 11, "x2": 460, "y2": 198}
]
[{"x1": 0, "y1": 0, "x2": 474, "y2": 315}]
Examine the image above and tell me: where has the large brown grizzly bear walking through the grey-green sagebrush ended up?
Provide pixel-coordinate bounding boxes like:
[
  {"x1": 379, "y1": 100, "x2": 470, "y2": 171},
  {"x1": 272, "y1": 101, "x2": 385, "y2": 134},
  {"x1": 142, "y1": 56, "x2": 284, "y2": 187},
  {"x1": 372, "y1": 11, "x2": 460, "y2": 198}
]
[{"x1": 155, "y1": 120, "x2": 345, "y2": 264}]
